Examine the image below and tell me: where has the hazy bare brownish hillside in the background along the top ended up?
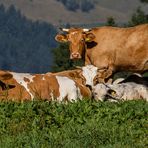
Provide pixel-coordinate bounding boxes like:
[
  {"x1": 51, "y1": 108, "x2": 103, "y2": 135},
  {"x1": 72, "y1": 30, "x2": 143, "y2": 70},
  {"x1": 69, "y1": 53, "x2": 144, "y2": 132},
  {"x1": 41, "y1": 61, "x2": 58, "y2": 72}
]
[{"x1": 0, "y1": 0, "x2": 148, "y2": 26}]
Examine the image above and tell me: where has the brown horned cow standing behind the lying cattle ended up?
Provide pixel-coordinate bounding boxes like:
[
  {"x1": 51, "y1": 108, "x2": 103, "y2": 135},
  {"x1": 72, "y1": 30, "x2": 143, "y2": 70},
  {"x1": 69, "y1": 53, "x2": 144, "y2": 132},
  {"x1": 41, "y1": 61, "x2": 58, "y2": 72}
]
[{"x1": 55, "y1": 24, "x2": 148, "y2": 81}]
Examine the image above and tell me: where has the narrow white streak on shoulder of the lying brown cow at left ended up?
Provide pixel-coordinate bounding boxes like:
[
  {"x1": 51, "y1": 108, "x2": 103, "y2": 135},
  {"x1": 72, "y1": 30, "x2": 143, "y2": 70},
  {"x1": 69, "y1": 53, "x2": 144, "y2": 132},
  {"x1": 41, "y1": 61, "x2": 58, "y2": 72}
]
[{"x1": 10, "y1": 72, "x2": 34, "y2": 99}]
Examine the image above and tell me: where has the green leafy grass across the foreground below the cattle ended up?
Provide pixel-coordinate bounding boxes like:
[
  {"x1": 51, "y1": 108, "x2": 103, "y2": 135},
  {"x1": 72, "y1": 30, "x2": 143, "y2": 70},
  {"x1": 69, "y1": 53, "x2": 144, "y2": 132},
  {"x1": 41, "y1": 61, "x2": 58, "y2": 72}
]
[{"x1": 0, "y1": 99, "x2": 148, "y2": 148}]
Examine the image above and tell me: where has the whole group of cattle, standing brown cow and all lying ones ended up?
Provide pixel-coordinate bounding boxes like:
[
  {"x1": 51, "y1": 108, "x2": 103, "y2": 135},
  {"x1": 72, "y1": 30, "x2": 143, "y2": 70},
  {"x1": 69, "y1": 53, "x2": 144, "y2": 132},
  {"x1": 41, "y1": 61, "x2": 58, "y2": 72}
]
[{"x1": 0, "y1": 24, "x2": 148, "y2": 102}]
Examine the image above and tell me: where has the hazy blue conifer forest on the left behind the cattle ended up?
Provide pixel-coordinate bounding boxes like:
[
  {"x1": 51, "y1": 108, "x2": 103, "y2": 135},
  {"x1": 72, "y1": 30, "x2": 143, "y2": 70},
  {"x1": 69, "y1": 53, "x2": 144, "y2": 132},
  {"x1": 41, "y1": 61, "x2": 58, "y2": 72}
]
[{"x1": 0, "y1": 5, "x2": 56, "y2": 73}]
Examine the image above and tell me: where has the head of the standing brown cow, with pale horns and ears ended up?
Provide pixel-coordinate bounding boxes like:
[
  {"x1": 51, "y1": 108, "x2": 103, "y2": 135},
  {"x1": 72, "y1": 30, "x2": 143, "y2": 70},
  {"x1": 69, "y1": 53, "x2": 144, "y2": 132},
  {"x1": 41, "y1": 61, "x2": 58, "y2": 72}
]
[{"x1": 55, "y1": 28, "x2": 95, "y2": 59}]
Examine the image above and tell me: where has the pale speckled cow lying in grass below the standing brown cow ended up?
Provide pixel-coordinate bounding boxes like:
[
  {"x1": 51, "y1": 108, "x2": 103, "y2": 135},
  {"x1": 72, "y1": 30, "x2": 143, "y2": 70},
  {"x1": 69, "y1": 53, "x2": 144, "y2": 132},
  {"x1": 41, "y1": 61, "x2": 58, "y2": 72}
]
[{"x1": 93, "y1": 75, "x2": 148, "y2": 101}]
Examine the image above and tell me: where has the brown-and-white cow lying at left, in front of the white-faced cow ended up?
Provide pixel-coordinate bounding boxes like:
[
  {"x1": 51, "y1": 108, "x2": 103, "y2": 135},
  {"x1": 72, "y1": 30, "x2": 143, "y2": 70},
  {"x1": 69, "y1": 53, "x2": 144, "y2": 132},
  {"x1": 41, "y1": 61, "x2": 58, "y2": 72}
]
[{"x1": 0, "y1": 71, "x2": 91, "y2": 101}]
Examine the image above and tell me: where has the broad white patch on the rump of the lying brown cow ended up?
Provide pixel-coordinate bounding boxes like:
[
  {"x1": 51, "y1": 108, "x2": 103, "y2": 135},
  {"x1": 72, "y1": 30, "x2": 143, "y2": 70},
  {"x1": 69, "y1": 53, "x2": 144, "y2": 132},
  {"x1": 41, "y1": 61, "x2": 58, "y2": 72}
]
[{"x1": 56, "y1": 76, "x2": 82, "y2": 101}]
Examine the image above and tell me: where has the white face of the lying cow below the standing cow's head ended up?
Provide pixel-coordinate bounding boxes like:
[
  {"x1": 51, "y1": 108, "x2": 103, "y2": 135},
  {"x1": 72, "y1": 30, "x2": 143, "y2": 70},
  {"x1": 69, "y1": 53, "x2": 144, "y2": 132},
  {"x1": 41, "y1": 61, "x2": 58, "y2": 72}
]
[{"x1": 82, "y1": 65, "x2": 98, "y2": 86}]
